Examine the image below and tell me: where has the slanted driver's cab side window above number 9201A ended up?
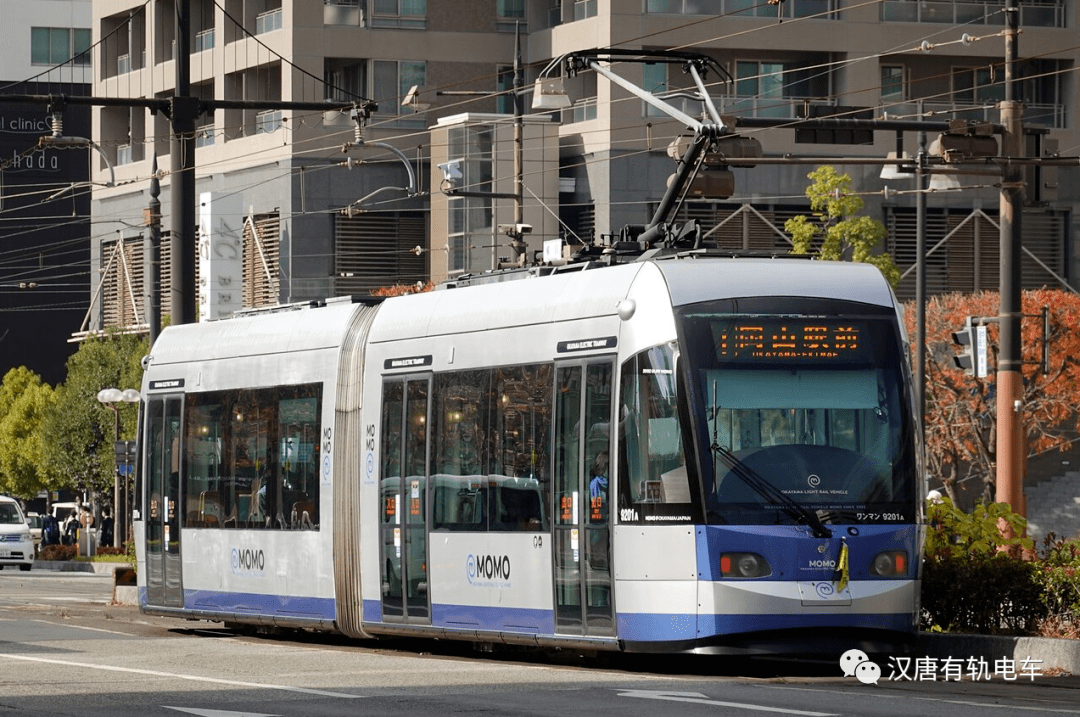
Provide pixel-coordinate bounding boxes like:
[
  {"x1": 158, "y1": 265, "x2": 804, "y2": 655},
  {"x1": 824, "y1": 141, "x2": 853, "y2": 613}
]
[{"x1": 619, "y1": 344, "x2": 692, "y2": 522}]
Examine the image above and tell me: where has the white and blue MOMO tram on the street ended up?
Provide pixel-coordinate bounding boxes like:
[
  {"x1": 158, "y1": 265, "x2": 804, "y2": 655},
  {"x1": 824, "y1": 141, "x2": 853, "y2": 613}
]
[{"x1": 135, "y1": 253, "x2": 924, "y2": 653}]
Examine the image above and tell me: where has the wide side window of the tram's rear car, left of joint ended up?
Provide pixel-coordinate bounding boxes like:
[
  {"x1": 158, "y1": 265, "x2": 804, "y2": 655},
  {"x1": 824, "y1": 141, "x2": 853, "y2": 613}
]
[{"x1": 185, "y1": 384, "x2": 322, "y2": 530}]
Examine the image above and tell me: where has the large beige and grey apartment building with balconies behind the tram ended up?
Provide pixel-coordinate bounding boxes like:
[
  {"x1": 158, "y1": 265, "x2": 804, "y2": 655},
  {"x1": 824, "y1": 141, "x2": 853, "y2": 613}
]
[{"x1": 93, "y1": 0, "x2": 1080, "y2": 326}]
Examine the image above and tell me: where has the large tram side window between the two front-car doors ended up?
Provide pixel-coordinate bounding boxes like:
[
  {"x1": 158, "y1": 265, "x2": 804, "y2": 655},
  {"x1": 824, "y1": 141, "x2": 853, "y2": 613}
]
[{"x1": 431, "y1": 365, "x2": 552, "y2": 531}]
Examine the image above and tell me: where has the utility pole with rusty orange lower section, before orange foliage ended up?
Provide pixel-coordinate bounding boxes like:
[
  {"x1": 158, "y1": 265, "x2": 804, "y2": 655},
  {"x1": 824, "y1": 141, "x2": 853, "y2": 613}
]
[{"x1": 996, "y1": 0, "x2": 1027, "y2": 515}]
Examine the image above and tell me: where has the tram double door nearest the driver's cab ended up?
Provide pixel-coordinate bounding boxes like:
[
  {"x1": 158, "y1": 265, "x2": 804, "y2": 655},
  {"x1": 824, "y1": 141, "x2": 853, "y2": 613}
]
[{"x1": 552, "y1": 360, "x2": 615, "y2": 636}]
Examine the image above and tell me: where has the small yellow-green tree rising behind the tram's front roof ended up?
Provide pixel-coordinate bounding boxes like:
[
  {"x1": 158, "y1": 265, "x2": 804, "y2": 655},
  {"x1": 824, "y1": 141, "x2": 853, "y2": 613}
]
[{"x1": 784, "y1": 165, "x2": 900, "y2": 286}]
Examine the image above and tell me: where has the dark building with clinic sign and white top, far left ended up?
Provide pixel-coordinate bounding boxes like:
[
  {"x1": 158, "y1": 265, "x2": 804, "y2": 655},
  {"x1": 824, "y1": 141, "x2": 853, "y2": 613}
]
[{"x1": 0, "y1": 0, "x2": 92, "y2": 384}]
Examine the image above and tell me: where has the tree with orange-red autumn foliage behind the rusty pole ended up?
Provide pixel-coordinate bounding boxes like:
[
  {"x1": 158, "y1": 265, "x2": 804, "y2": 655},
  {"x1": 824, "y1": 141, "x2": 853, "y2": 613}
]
[{"x1": 905, "y1": 289, "x2": 1080, "y2": 502}]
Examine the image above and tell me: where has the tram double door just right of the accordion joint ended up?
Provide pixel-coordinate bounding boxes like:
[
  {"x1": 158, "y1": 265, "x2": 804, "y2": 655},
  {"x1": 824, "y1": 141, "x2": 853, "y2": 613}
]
[{"x1": 379, "y1": 377, "x2": 431, "y2": 624}]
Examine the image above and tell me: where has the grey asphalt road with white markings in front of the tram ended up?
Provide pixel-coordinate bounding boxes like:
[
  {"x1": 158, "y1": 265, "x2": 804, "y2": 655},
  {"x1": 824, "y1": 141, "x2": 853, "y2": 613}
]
[{"x1": 0, "y1": 570, "x2": 1080, "y2": 717}]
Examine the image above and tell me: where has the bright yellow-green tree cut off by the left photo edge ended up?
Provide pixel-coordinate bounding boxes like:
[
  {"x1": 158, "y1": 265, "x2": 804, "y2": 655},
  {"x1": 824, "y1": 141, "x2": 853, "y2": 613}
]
[{"x1": 0, "y1": 366, "x2": 55, "y2": 498}]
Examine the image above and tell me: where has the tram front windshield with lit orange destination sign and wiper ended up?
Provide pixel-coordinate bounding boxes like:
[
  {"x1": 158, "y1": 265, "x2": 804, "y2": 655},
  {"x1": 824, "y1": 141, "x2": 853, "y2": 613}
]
[{"x1": 680, "y1": 299, "x2": 916, "y2": 525}]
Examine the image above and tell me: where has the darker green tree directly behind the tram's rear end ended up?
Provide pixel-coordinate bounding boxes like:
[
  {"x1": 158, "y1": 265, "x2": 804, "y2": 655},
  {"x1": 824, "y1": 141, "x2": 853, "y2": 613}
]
[{"x1": 43, "y1": 334, "x2": 148, "y2": 501}]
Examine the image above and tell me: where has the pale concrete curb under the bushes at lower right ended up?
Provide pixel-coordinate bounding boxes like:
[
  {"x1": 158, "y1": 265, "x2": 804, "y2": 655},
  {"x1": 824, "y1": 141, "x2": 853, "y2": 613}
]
[{"x1": 916, "y1": 633, "x2": 1080, "y2": 675}]
